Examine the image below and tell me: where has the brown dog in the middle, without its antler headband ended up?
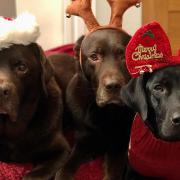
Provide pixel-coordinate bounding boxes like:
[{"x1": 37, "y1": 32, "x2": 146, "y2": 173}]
[{"x1": 56, "y1": 29, "x2": 134, "y2": 180}]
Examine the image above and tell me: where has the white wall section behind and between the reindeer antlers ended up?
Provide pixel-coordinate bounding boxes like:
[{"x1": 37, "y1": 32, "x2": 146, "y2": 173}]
[{"x1": 64, "y1": 0, "x2": 142, "y2": 43}]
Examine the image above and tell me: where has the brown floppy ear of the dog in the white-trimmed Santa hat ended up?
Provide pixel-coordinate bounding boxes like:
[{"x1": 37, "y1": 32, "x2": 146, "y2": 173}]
[{"x1": 30, "y1": 43, "x2": 54, "y2": 95}]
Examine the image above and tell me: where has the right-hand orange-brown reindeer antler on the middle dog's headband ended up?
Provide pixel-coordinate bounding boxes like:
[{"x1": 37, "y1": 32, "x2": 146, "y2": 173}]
[{"x1": 107, "y1": 0, "x2": 141, "y2": 28}]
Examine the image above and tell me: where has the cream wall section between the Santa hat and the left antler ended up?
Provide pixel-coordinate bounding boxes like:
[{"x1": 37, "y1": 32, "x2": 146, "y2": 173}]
[{"x1": 16, "y1": 0, "x2": 64, "y2": 50}]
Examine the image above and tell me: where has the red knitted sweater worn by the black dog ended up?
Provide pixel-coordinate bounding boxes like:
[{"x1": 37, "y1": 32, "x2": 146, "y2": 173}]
[{"x1": 129, "y1": 114, "x2": 180, "y2": 180}]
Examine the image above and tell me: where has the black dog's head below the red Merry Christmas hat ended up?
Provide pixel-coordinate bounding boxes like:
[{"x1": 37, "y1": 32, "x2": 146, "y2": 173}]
[{"x1": 121, "y1": 65, "x2": 180, "y2": 141}]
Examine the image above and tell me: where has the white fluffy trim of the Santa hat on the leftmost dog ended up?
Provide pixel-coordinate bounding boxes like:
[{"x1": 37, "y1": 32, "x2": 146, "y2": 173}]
[{"x1": 0, "y1": 12, "x2": 40, "y2": 50}]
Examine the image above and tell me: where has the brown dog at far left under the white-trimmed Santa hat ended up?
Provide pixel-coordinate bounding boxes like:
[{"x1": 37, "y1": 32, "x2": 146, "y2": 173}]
[{"x1": 0, "y1": 43, "x2": 69, "y2": 180}]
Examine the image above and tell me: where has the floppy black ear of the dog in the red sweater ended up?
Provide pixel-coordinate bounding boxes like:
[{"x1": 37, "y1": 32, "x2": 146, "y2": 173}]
[{"x1": 121, "y1": 76, "x2": 148, "y2": 121}]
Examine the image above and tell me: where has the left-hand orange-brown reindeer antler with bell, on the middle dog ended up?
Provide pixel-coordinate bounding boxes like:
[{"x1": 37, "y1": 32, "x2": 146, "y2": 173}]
[{"x1": 66, "y1": 0, "x2": 100, "y2": 31}]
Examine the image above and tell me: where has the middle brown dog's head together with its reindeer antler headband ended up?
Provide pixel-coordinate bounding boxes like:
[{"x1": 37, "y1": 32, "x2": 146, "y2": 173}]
[{"x1": 66, "y1": 0, "x2": 140, "y2": 107}]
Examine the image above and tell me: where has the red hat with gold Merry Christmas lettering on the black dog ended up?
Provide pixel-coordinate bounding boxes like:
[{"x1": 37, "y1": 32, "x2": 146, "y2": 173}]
[{"x1": 126, "y1": 22, "x2": 180, "y2": 77}]
